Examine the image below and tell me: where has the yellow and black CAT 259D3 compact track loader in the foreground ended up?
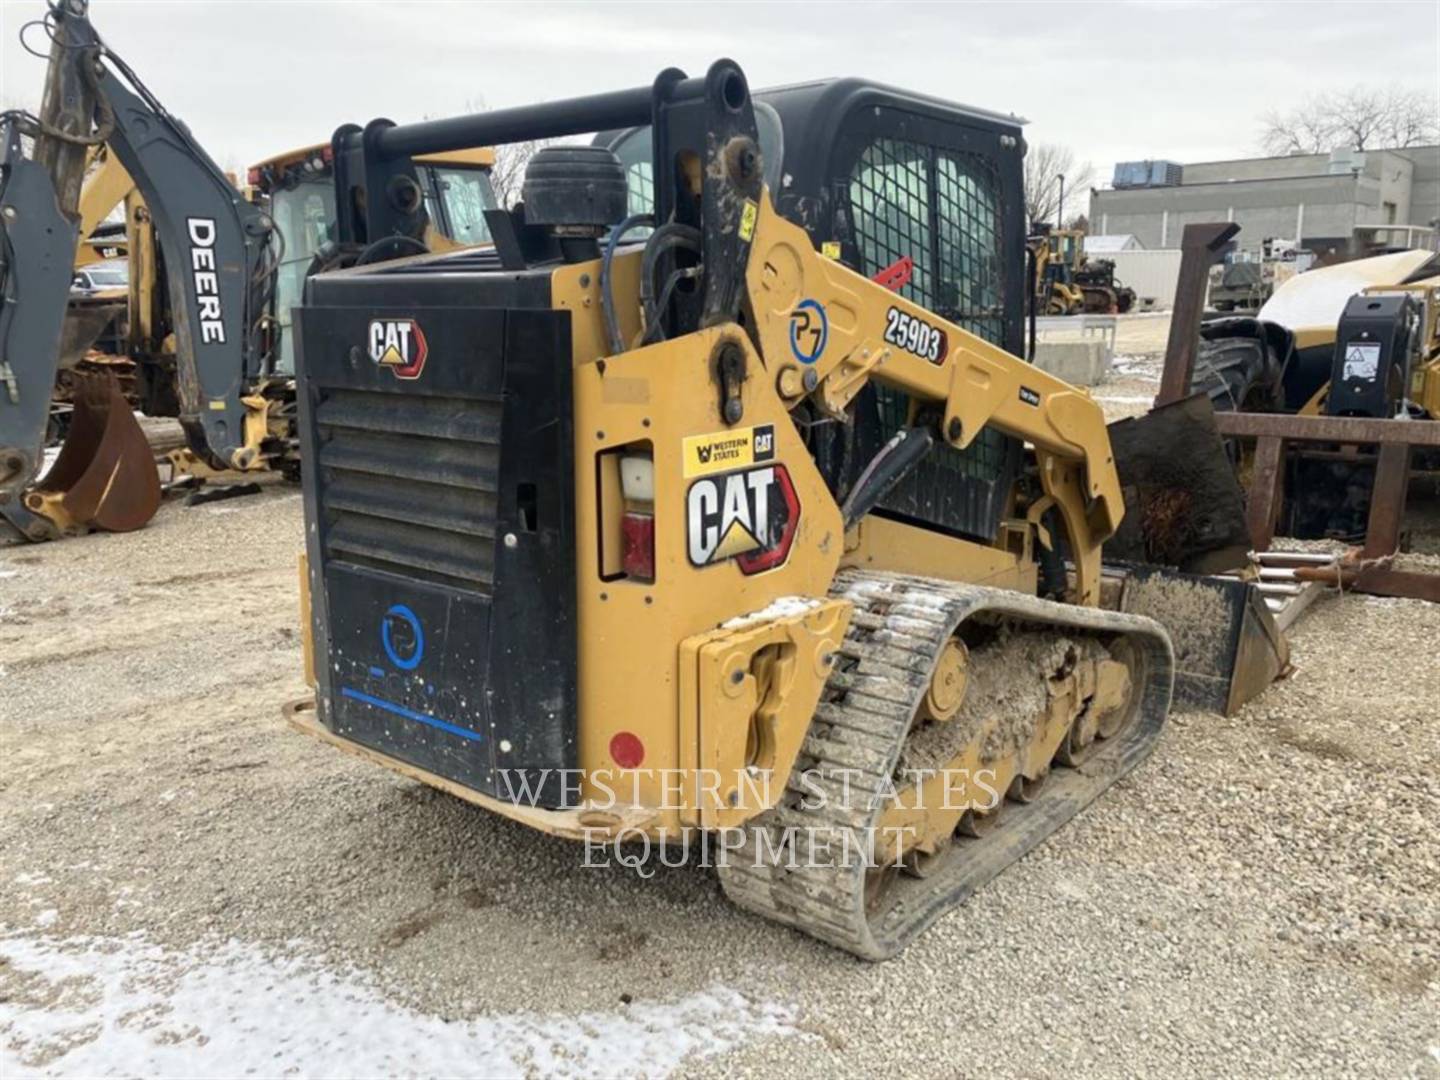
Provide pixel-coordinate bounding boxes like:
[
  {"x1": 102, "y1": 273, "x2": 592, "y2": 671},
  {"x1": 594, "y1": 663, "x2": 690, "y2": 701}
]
[{"x1": 287, "y1": 60, "x2": 1174, "y2": 959}]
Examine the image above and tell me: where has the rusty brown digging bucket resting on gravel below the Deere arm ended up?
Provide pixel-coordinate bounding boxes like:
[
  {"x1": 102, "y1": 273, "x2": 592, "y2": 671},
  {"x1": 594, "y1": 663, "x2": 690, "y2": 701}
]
[{"x1": 24, "y1": 373, "x2": 160, "y2": 533}]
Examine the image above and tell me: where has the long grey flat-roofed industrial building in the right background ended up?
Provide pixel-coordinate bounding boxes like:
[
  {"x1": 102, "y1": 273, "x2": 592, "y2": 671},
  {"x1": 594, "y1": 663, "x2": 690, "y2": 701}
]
[{"x1": 1090, "y1": 145, "x2": 1440, "y2": 262}]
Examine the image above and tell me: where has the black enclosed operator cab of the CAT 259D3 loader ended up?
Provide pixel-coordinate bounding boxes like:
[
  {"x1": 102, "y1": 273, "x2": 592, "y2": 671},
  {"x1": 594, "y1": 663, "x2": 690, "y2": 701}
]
[{"x1": 595, "y1": 78, "x2": 1025, "y2": 540}]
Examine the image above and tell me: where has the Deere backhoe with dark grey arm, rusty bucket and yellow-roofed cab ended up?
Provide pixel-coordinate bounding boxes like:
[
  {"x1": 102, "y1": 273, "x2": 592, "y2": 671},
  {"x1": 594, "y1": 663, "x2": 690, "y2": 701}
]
[{"x1": 0, "y1": 0, "x2": 492, "y2": 540}]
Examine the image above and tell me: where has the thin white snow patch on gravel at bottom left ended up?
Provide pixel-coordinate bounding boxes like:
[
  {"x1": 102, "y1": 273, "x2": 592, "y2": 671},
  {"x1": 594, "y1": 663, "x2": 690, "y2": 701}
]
[{"x1": 0, "y1": 935, "x2": 798, "y2": 1080}]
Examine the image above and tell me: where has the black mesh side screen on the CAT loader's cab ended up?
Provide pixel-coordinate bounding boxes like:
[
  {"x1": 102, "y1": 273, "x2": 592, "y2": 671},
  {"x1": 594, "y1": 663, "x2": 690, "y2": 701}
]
[{"x1": 850, "y1": 138, "x2": 1018, "y2": 539}]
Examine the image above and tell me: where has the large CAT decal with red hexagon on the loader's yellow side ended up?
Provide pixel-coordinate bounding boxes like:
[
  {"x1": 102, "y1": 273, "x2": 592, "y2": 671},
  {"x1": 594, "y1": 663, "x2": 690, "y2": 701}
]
[{"x1": 685, "y1": 465, "x2": 801, "y2": 575}]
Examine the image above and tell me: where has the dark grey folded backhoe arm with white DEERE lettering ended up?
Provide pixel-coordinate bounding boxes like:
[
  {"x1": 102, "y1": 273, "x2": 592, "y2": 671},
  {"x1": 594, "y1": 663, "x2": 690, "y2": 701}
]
[{"x1": 0, "y1": 0, "x2": 274, "y2": 536}]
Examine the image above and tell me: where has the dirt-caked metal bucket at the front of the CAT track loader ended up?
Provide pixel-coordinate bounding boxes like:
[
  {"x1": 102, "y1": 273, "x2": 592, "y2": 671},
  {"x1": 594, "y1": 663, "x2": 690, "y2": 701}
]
[{"x1": 1120, "y1": 566, "x2": 1290, "y2": 716}]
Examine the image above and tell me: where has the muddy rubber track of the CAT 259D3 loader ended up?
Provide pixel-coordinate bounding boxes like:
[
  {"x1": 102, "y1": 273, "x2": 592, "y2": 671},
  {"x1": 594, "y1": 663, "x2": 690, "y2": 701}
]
[{"x1": 719, "y1": 570, "x2": 1174, "y2": 960}]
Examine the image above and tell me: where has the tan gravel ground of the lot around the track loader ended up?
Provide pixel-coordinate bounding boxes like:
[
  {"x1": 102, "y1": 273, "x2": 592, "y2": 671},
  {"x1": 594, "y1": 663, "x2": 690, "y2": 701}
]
[{"x1": 0, "y1": 368, "x2": 1440, "y2": 1077}]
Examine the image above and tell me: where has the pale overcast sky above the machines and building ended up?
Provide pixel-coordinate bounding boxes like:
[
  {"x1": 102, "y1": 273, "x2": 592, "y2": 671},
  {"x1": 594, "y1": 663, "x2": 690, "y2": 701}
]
[{"x1": 0, "y1": 0, "x2": 1440, "y2": 211}]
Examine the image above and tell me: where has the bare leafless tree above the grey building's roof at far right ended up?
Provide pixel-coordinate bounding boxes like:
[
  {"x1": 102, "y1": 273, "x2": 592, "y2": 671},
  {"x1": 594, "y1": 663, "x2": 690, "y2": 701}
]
[{"x1": 1260, "y1": 86, "x2": 1440, "y2": 154}]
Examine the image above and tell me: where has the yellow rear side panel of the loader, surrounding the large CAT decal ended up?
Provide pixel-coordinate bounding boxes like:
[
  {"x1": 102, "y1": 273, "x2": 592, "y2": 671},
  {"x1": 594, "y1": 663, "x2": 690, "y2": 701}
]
[{"x1": 553, "y1": 253, "x2": 844, "y2": 828}]
